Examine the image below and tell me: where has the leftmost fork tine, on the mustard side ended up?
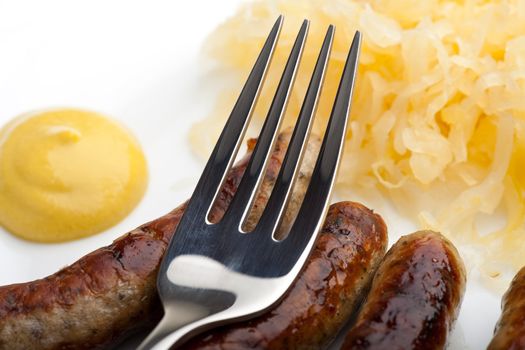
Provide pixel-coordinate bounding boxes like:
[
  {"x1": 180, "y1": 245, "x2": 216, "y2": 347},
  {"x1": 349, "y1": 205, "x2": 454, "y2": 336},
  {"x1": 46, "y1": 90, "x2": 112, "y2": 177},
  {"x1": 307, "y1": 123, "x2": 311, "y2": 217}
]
[{"x1": 186, "y1": 15, "x2": 283, "y2": 218}]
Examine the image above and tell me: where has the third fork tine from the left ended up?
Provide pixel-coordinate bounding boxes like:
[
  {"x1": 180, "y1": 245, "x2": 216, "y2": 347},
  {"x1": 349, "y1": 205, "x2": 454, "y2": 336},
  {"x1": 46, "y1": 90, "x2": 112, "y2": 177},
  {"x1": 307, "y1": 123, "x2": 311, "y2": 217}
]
[{"x1": 255, "y1": 25, "x2": 335, "y2": 237}]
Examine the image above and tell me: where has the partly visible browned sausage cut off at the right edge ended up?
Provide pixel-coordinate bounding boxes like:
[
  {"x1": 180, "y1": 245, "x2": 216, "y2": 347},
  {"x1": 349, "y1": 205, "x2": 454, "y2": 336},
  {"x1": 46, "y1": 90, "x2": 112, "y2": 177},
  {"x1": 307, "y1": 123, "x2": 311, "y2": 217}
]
[{"x1": 487, "y1": 268, "x2": 525, "y2": 350}]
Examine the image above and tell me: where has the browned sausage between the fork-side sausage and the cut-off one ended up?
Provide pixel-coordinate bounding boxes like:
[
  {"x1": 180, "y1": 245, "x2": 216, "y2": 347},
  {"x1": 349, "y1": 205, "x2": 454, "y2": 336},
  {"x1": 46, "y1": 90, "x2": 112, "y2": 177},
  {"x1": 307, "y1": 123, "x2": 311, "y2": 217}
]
[{"x1": 342, "y1": 231, "x2": 466, "y2": 350}]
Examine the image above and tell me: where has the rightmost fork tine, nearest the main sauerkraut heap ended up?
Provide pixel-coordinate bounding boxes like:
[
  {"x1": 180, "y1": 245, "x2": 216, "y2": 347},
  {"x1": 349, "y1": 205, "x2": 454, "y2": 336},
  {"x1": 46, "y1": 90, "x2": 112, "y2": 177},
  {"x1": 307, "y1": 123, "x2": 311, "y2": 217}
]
[{"x1": 281, "y1": 32, "x2": 361, "y2": 262}]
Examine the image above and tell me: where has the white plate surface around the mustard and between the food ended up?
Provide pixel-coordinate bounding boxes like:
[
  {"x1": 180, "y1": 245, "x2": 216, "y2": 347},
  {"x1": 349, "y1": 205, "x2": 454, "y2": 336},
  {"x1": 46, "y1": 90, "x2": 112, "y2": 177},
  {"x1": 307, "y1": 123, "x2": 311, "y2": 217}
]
[{"x1": 0, "y1": 0, "x2": 501, "y2": 349}]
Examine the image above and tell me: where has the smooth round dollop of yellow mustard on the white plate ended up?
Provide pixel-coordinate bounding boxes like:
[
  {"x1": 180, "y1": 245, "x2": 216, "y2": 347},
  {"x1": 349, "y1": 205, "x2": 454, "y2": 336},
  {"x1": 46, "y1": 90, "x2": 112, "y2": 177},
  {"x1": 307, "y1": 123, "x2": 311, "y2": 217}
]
[{"x1": 0, "y1": 109, "x2": 147, "y2": 242}]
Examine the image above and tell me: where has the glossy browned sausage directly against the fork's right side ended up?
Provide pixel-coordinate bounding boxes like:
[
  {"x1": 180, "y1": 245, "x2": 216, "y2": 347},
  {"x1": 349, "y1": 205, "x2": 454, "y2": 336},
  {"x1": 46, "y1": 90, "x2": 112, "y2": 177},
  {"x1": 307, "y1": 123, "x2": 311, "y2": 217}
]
[{"x1": 182, "y1": 202, "x2": 387, "y2": 350}]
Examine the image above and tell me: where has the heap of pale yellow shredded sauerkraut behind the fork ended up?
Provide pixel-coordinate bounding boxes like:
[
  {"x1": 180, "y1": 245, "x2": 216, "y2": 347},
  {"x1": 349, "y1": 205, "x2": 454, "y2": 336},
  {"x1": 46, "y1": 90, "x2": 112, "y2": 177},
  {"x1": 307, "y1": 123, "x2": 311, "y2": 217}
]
[{"x1": 191, "y1": 0, "x2": 525, "y2": 276}]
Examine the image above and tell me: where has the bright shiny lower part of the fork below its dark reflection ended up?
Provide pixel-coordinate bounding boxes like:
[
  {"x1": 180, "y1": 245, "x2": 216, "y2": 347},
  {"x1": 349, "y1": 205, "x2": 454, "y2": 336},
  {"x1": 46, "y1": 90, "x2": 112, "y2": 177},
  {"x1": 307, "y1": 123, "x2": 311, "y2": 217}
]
[{"x1": 139, "y1": 255, "x2": 292, "y2": 350}]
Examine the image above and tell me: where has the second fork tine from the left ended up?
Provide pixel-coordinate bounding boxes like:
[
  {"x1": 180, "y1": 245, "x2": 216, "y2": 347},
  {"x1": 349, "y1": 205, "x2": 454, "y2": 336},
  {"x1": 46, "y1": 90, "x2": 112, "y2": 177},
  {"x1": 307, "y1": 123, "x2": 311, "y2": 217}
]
[{"x1": 223, "y1": 20, "x2": 309, "y2": 231}]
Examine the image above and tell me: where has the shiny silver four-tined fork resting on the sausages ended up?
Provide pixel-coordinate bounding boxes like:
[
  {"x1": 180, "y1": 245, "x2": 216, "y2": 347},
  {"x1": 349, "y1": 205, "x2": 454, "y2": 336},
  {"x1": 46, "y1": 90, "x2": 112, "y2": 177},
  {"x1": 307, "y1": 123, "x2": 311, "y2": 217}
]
[{"x1": 139, "y1": 16, "x2": 361, "y2": 350}]
